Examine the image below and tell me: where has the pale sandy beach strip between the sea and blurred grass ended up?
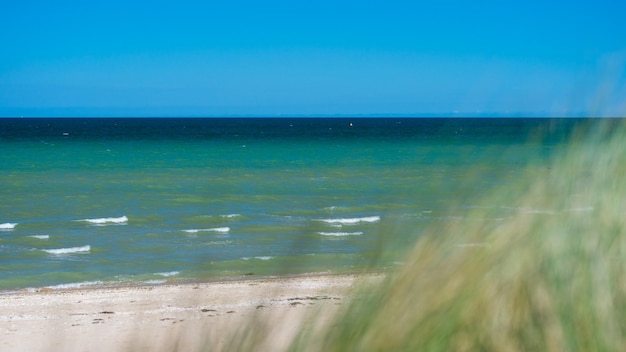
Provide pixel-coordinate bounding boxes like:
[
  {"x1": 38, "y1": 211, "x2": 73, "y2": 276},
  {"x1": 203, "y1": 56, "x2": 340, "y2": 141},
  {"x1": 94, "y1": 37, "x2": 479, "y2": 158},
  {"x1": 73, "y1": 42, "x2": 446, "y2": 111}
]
[{"x1": 0, "y1": 275, "x2": 382, "y2": 352}]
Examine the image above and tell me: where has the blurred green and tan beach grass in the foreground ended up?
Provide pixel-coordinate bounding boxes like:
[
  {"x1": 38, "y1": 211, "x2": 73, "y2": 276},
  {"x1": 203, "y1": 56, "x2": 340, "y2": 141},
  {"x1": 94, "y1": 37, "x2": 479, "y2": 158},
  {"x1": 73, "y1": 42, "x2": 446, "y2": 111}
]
[{"x1": 212, "y1": 120, "x2": 626, "y2": 351}]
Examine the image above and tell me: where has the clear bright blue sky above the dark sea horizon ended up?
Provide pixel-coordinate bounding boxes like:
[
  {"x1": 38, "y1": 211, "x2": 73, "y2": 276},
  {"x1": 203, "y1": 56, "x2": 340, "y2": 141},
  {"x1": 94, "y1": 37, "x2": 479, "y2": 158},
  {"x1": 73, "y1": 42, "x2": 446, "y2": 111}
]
[{"x1": 0, "y1": 0, "x2": 626, "y2": 116}]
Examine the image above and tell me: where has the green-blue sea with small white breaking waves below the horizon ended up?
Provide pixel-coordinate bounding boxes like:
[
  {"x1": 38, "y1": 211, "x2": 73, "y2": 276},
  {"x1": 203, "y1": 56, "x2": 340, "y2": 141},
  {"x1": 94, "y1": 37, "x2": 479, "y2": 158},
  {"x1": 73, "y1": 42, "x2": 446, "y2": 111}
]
[{"x1": 0, "y1": 117, "x2": 585, "y2": 291}]
